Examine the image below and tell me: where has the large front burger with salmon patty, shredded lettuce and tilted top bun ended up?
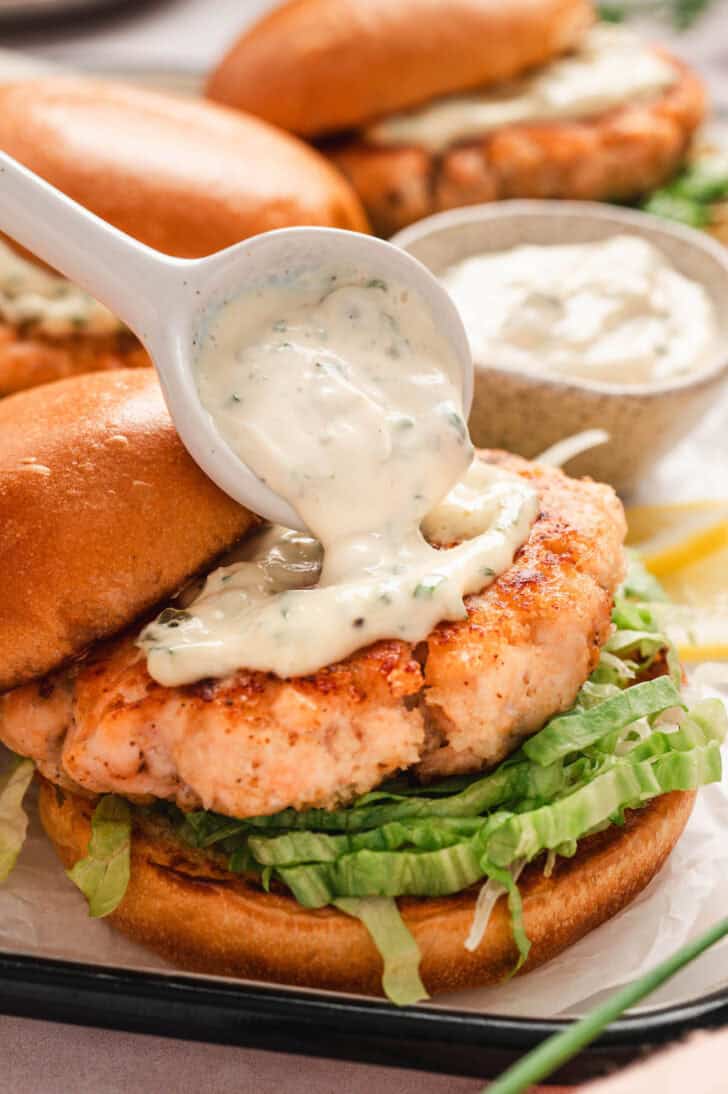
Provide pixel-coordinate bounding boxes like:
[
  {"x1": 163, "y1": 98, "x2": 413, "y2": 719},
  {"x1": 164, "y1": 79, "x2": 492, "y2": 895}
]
[{"x1": 0, "y1": 363, "x2": 726, "y2": 1003}]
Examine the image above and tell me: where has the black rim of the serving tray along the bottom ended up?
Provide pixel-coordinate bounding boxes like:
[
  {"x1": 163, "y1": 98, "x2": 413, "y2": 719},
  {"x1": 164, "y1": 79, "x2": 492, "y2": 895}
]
[{"x1": 0, "y1": 953, "x2": 728, "y2": 1082}]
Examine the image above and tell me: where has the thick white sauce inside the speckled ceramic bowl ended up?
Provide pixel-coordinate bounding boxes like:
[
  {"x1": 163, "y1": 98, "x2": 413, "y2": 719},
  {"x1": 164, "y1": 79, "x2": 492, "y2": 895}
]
[{"x1": 442, "y1": 235, "x2": 718, "y2": 384}]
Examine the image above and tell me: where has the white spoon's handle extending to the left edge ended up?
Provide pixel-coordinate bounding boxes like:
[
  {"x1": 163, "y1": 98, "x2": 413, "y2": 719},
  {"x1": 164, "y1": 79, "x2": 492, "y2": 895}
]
[{"x1": 0, "y1": 152, "x2": 178, "y2": 342}]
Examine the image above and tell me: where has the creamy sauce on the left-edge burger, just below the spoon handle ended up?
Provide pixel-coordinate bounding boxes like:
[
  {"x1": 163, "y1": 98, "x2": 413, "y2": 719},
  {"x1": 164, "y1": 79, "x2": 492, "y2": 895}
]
[{"x1": 0, "y1": 242, "x2": 122, "y2": 338}]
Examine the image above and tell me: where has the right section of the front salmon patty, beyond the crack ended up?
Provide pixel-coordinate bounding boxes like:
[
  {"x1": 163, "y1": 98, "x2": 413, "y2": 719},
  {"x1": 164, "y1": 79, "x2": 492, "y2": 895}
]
[{"x1": 419, "y1": 452, "x2": 626, "y2": 778}]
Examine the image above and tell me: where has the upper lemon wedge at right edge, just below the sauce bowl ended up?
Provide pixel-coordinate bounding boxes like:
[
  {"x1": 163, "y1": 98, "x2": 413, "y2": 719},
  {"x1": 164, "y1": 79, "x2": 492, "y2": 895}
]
[{"x1": 627, "y1": 501, "x2": 728, "y2": 584}]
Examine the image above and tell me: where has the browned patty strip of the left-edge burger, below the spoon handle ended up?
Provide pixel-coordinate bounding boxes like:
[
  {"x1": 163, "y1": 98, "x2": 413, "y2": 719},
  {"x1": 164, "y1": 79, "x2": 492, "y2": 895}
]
[{"x1": 0, "y1": 323, "x2": 151, "y2": 396}]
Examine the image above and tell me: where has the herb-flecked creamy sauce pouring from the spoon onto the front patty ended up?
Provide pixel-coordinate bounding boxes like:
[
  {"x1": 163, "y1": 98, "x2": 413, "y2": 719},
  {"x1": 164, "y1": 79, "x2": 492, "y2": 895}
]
[{"x1": 140, "y1": 270, "x2": 538, "y2": 673}]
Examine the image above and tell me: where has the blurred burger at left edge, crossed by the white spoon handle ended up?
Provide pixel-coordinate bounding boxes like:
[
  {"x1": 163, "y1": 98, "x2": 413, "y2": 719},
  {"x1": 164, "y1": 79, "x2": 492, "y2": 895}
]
[{"x1": 0, "y1": 75, "x2": 368, "y2": 395}]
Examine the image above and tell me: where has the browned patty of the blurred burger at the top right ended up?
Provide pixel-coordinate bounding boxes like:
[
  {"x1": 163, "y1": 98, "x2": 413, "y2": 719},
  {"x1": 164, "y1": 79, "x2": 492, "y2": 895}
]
[{"x1": 327, "y1": 55, "x2": 706, "y2": 236}]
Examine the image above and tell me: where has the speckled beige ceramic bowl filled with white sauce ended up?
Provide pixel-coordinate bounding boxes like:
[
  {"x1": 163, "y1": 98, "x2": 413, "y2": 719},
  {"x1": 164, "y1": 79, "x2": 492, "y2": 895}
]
[{"x1": 392, "y1": 201, "x2": 728, "y2": 491}]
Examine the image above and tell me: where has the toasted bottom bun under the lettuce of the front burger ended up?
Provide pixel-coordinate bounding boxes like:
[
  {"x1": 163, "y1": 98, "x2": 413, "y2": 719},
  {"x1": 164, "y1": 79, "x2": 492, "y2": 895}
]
[{"x1": 41, "y1": 781, "x2": 695, "y2": 994}]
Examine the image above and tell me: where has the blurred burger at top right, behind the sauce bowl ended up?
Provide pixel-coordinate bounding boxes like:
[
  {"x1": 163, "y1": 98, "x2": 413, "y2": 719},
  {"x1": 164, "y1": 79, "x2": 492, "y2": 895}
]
[{"x1": 207, "y1": 0, "x2": 705, "y2": 236}]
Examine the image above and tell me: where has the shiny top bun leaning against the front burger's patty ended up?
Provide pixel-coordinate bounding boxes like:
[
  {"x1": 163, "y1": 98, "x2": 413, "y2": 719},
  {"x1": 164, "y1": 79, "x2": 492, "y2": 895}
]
[{"x1": 0, "y1": 369, "x2": 254, "y2": 689}]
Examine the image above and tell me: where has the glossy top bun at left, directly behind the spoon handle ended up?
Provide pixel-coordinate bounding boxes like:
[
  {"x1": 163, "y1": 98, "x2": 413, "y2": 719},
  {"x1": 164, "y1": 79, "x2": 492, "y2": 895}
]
[{"x1": 0, "y1": 77, "x2": 367, "y2": 258}]
